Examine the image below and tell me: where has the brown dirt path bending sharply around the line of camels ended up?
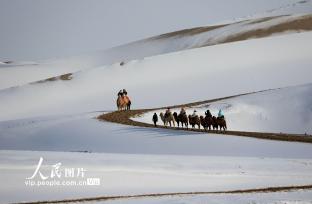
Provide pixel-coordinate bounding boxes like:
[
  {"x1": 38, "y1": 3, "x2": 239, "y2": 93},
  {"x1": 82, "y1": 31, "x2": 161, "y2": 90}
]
[{"x1": 97, "y1": 90, "x2": 312, "y2": 143}]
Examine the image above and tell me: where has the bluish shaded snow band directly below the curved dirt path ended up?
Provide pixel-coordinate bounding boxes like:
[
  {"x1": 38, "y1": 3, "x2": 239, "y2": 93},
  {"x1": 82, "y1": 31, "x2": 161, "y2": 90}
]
[{"x1": 0, "y1": 112, "x2": 312, "y2": 159}]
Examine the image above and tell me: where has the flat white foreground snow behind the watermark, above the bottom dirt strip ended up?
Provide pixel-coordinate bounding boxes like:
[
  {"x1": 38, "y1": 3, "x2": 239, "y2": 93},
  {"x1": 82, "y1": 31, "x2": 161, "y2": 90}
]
[{"x1": 0, "y1": 150, "x2": 312, "y2": 202}]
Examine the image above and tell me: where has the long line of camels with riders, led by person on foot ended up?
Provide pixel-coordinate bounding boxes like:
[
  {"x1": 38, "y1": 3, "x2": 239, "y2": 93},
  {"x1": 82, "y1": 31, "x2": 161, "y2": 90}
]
[{"x1": 152, "y1": 108, "x2": 227, "y2": 131}]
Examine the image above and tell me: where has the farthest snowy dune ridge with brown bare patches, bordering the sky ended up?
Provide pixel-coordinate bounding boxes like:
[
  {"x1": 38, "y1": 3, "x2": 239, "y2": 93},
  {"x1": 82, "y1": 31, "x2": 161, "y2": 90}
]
[{"x1": 0, "y1": 12, "x2": 312, "y2": 89}]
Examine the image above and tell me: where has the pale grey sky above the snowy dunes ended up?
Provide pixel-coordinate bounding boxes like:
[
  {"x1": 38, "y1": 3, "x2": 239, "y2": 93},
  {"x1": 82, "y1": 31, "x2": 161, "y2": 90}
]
[{"x1": 0, "y1": 0, "x2": 300, "y2": 61}]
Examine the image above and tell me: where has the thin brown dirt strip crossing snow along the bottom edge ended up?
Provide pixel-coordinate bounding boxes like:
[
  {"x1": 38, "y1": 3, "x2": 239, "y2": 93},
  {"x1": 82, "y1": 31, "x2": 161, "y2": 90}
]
[{"x1": 18, "y1": 185, "x2": 312, "y2": 204}]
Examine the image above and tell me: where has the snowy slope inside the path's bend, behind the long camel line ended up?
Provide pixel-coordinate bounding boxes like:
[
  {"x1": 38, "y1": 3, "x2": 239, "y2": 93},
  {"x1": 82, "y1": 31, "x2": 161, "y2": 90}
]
[{"x1": 133, "y1": 84, "x2": 312, "y2": 134}]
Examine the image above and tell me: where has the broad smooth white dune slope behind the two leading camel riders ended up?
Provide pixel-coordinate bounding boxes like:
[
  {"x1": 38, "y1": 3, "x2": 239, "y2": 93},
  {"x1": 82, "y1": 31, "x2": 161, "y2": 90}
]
[{"x1": 0, "y1": 32, "x2": 312, "y2": 121}]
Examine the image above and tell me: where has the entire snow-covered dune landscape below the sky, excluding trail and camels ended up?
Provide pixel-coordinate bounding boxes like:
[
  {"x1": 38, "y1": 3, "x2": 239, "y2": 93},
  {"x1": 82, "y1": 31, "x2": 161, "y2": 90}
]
[{"x1": 0, "y1": 0, "x2": 312, "y2": 203}]
